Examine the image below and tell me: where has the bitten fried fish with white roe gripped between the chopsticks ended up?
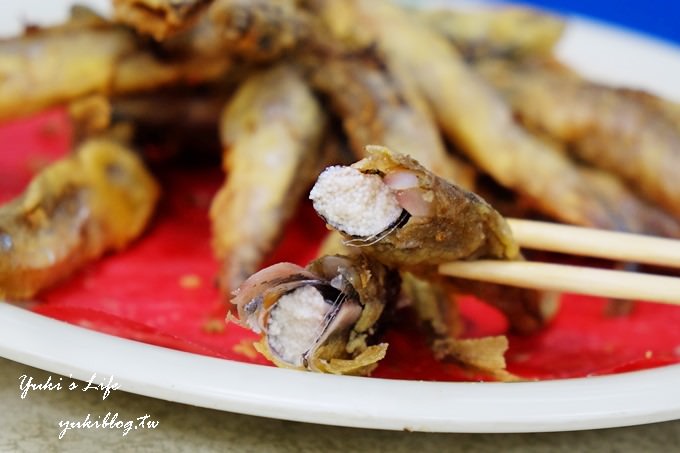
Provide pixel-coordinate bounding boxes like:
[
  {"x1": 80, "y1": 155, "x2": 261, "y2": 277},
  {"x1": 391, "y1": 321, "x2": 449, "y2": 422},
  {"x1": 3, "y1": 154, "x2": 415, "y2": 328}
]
[{"x1": 310, "y1": 146, "x2": 555, "y2": 333}]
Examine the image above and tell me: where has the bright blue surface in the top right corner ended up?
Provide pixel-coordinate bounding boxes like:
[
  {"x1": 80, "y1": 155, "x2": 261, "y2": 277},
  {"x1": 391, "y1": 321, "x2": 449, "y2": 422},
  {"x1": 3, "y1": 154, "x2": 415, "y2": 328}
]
[{"x1": 518, "y1": 0, "x2": 680, "y2": 44}]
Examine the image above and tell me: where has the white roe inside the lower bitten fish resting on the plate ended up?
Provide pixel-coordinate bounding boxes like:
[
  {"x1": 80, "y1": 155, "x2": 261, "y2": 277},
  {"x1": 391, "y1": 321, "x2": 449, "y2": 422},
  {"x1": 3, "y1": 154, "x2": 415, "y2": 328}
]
[{"x1": 267, "y1": 286, "x2": 331, "y2": 366}]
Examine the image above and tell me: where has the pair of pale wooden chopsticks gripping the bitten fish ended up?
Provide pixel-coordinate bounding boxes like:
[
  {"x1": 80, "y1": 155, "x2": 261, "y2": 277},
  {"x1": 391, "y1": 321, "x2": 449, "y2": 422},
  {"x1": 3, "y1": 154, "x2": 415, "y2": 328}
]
[{"x1": 439, "y1": 219, "x2": 680, "y2": 305}]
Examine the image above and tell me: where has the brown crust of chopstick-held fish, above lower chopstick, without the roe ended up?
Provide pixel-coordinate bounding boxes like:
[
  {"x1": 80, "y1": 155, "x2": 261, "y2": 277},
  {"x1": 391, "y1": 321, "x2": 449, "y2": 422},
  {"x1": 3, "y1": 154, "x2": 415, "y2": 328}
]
[{"x1": 353, "y1": 147, "x2": 520, "y2": 268}]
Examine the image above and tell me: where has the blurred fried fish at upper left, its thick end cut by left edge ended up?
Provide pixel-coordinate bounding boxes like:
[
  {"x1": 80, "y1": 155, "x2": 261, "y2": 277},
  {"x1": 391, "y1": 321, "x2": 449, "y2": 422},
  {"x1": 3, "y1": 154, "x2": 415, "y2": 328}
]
[{"x1": 0, "y1": 17, "x2": 231, "y2": 119}]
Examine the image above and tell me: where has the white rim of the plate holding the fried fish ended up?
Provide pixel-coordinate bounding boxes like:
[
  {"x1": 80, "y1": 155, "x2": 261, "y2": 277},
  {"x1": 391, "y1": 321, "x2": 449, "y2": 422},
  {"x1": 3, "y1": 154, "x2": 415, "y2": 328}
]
[{"x1": 0, "y1": 1, "x2": 680, "y2": 433}]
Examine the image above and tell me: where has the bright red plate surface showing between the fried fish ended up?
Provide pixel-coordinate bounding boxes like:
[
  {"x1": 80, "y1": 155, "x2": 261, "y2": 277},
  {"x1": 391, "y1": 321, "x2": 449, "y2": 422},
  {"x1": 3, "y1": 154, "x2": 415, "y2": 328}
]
[{"x1": 0, "y1": 111, "x2": 680, "y2": 380}]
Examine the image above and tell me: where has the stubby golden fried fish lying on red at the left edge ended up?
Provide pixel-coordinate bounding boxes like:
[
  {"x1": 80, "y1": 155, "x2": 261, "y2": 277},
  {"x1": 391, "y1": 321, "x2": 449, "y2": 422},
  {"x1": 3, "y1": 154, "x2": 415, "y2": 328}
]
[{"x1": 0, "y1": 139, "x2": 159, "y2": 300}]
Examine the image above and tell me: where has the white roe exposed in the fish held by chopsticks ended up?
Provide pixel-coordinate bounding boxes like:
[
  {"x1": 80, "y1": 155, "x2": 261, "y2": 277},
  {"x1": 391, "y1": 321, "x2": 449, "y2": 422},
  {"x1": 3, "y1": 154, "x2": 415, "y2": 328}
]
[{"x1": 309, "y1": 166, "x2": 402, "y2": 237}]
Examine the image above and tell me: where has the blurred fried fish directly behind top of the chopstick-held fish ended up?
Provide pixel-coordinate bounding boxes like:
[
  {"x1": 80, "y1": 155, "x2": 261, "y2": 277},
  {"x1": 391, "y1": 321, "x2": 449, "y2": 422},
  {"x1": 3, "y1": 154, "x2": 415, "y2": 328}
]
[{"x1": 312, "y1": 55, "x2": 475, "y2": 188}]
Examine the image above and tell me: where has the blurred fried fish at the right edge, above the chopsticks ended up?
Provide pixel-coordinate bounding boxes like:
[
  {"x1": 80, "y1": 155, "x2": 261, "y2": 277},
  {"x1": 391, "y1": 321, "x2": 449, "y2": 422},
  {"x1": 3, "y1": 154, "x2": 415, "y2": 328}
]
[{"x1": 479, "y1": 59, "x2": 680, "y2": 222}]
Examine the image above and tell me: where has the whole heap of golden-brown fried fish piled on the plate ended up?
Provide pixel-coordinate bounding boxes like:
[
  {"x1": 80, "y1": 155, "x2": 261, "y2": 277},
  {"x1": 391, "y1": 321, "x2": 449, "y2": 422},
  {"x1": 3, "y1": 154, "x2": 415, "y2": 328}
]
[{"x1": 0, "y1": 0, "x2": 680, "y2": 380}]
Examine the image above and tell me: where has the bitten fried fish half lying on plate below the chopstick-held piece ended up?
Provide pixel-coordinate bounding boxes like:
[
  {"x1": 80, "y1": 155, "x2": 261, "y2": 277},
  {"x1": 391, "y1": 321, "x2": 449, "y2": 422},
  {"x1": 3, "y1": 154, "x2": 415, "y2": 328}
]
[{"x1": 232, "y1": 256, "x2": 399, "y2": 375}]
